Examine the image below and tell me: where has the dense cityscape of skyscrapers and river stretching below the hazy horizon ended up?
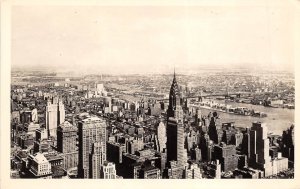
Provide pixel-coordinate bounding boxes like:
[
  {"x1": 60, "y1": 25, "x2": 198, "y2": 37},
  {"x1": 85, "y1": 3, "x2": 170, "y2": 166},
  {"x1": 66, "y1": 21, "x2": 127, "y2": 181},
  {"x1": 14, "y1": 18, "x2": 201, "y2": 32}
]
[{"x1": 10, "y1": 69, "x2": 295, "y2": 179}]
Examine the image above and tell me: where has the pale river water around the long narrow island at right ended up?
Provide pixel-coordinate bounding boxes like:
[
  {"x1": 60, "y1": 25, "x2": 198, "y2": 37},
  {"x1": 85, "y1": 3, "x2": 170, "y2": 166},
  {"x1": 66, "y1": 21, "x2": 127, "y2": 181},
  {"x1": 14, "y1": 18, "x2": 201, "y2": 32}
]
[{"x1": 201, "y1": 100, "x2": 295, "y2": 135}]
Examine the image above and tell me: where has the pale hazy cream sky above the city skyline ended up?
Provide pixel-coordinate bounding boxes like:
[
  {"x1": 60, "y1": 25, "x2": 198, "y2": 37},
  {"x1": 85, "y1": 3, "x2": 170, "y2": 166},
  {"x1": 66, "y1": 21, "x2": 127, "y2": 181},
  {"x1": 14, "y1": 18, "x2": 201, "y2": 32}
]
[{"x1": 12, "y1": 6, "x2": 295, "y2": 73}]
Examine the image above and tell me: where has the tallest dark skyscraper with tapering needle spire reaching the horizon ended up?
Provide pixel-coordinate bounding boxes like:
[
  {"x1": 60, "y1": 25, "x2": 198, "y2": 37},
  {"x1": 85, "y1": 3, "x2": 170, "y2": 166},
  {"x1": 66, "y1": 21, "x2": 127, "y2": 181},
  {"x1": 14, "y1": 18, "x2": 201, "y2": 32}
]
[{"x1": 167, "y1": 70, "x2": 187, "y2": 170}]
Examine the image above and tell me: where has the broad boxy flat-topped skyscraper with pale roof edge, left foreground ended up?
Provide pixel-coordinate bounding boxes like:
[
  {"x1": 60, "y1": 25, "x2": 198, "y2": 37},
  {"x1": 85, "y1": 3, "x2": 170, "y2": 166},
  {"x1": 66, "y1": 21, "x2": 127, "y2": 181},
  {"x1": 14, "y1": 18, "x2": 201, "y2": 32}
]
[{"x1": 78, "y1": 117, "x2": 106, "y2": 178}]
